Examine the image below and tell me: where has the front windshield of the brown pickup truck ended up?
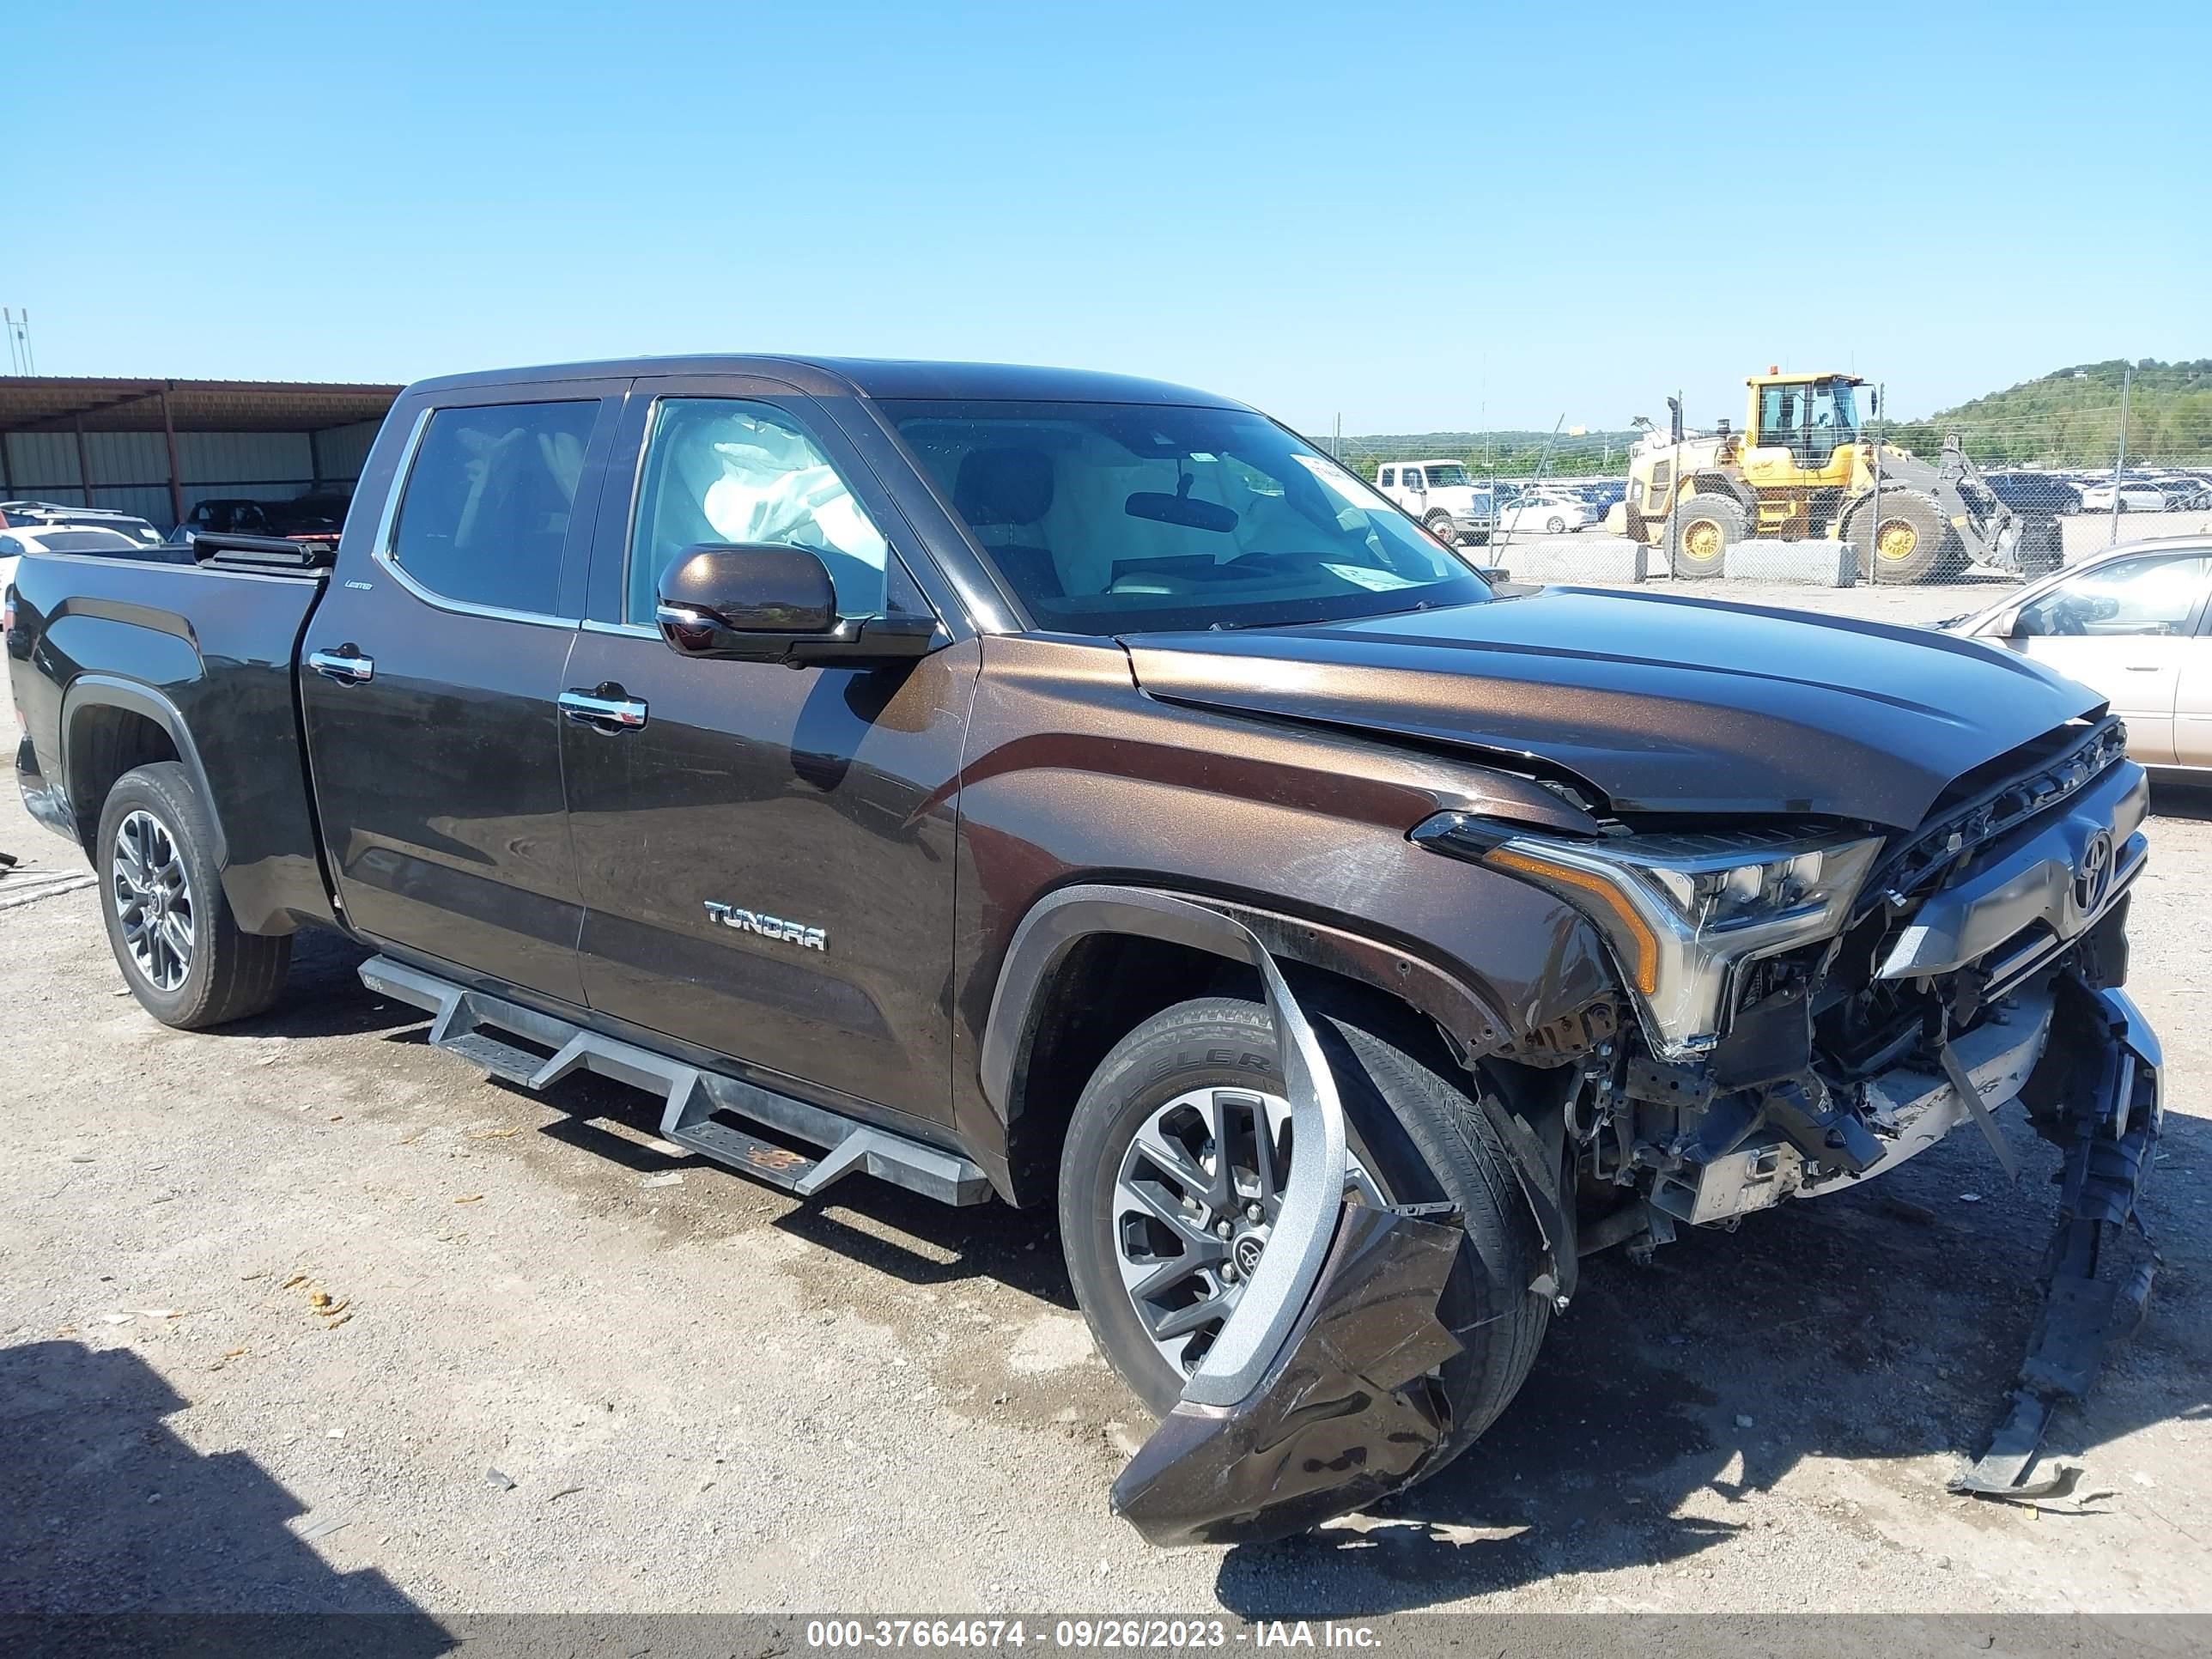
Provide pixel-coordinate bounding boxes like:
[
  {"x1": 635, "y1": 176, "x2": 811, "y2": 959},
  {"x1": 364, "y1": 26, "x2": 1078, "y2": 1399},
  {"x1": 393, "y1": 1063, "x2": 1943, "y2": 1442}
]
[{"x1": 880, "y1": 400, "x2": 1491, "y2": 633}]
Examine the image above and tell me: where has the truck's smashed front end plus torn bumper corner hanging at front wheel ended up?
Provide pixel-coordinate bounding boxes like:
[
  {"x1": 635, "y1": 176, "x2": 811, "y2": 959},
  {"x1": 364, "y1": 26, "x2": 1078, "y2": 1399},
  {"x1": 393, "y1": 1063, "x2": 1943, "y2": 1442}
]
[{"x1": 1115, "y1": 719, "x2": 2161, "y2": 1544}]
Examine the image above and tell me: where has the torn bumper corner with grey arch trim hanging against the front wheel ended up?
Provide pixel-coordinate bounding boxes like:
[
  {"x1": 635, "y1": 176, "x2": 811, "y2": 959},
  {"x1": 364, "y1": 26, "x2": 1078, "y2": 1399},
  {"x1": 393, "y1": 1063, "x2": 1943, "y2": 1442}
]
[{"x1": 1113, "y1": 915, "x2": 1467, "y2": 1544}]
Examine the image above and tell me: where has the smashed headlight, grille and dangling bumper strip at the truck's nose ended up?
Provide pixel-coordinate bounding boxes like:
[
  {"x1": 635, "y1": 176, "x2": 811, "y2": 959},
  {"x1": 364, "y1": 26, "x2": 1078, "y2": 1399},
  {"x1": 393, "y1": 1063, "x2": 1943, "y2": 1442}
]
[{"x1": 1416, "y1": 717, "x2": 2163, "y2": 1498}]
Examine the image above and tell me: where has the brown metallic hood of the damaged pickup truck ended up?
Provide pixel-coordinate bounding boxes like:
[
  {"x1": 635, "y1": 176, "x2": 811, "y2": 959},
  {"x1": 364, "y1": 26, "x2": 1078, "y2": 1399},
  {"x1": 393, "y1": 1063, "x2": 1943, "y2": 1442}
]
[{"x1": 1121, "y1": 588, "x2": 2101, "y2": 830}]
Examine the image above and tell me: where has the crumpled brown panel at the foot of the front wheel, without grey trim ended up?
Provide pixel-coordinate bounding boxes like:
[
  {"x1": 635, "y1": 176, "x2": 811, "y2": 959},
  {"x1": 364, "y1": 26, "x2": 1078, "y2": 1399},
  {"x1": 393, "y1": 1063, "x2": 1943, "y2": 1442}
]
[{"x1": 1113, "y1": 1201, "x2": 1467, "y2": 1547}]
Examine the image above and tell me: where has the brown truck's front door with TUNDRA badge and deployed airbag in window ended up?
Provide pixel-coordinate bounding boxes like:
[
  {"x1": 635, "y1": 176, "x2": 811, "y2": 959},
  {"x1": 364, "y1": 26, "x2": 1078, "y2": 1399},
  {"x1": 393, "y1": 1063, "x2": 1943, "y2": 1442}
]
[{"x1": 562, "y1": 376, "x2": 980, "y2": 1119}]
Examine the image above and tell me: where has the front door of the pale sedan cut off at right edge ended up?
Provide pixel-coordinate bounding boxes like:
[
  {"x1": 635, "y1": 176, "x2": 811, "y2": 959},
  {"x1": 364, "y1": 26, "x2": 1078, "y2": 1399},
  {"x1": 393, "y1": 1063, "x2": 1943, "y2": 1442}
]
[{"x1": 2006, "y1": 553, "x2": 2212, "y2": 765}]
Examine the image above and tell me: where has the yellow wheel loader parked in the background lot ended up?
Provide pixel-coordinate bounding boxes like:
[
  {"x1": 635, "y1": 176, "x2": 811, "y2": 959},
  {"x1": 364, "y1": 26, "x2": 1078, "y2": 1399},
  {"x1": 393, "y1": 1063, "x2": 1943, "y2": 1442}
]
[{"x1": 1614, "y1": 369, "x2": 2026, "y2": 581}]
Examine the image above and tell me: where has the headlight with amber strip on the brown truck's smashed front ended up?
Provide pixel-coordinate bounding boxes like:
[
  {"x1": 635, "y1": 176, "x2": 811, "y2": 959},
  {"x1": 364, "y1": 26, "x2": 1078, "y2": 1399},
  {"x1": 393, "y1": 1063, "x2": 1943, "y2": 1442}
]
[{"x1": 1413, "y1": 811, "x2": 1882, "y2": 1060}]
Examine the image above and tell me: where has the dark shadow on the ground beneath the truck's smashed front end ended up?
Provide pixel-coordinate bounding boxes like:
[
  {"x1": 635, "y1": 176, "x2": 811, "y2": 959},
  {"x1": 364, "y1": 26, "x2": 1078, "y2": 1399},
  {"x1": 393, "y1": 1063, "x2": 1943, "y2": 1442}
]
[{"x1": 1217, "y1": 1115, "x2": 2212, "y2": 1620}]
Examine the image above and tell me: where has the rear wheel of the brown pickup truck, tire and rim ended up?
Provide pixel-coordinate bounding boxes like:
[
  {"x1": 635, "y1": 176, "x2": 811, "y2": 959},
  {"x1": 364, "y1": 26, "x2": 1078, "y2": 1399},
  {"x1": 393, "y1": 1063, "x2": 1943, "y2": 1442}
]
[{"x1": 93, "y1": 761, "x2": 292, "y2": 1030}]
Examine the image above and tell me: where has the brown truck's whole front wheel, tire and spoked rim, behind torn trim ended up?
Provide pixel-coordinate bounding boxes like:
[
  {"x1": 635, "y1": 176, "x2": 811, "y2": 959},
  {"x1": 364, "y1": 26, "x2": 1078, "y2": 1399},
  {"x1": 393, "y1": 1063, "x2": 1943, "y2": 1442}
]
[{"x1": 1060, "y1": 998, "x2": 1551, "y2": 1467}]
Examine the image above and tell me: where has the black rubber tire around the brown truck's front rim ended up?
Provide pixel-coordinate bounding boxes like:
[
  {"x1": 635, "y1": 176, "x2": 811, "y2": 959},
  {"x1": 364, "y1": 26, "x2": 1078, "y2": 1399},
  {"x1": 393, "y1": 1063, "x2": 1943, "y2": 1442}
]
[{"x1": 1060, "y1": 998, "x2": 1551, "y2": 1467}]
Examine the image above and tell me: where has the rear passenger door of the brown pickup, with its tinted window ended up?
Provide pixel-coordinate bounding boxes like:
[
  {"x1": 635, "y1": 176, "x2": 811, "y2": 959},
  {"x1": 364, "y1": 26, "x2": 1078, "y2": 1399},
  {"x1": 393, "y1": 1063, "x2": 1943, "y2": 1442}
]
[{"x1": 301, "y1": 380, "x2": 629, "y2": 1005}]
